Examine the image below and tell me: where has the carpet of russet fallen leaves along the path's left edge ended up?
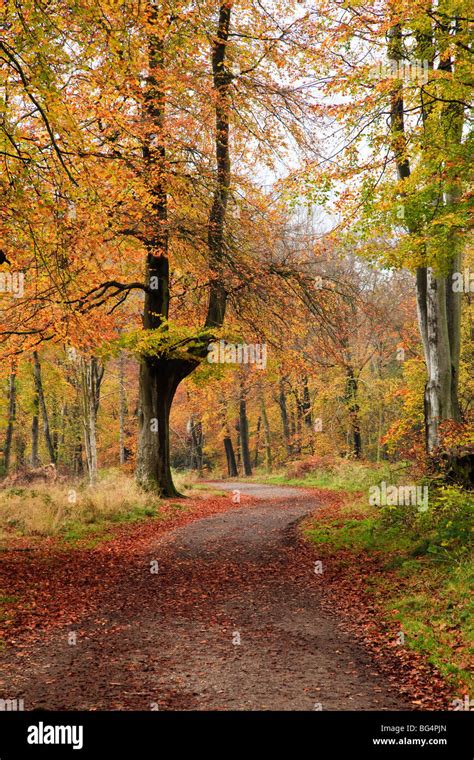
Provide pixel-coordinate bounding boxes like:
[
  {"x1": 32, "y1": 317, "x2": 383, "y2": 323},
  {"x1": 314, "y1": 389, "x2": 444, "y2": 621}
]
[{"x1": 0, "y1": 496, "x2": 235, "y2": 646}]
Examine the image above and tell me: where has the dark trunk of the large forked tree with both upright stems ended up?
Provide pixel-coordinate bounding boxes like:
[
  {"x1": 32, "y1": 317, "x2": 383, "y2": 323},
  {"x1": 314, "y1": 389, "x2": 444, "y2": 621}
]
[{"x1": 137, "y1": 2, "x2": 232, "y2": 497}]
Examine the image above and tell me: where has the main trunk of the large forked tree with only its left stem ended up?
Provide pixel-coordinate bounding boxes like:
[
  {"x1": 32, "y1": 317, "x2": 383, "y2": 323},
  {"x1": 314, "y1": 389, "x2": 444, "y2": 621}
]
[{"x1": 136, "y1": 10, "x2": 185, "y2": 497}]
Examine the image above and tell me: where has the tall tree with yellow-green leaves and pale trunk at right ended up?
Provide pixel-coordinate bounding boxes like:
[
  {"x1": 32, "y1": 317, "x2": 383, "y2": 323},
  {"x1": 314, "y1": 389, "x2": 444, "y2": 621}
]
[{"x1": 301, "y1": 0, "x2": 472, "y2": 451}]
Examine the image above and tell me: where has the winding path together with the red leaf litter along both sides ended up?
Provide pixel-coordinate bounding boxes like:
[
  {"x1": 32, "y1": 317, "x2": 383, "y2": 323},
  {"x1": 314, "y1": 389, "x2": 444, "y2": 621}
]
[{"x1": 0, "y1": 481, "x2": 453, "y2": 710}]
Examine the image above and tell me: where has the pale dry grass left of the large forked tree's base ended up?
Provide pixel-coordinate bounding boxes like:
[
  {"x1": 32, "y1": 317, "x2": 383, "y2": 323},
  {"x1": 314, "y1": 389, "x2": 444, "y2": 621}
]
[{"x1": 0, "y1": 471, "x2": 160, "y2": 537}]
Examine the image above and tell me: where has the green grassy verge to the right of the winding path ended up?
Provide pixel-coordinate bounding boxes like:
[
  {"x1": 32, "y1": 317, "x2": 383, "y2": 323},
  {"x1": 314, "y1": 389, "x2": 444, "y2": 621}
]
[{"x1": 304, "y1": 480, "x2": 474, "y2": 693}]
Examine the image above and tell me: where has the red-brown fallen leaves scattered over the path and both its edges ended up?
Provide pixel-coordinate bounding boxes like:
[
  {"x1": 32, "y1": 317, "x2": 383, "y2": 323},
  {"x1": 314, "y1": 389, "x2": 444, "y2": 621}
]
[{"x1": 0, "y1": 491, "x2": 460, "y2": 710}]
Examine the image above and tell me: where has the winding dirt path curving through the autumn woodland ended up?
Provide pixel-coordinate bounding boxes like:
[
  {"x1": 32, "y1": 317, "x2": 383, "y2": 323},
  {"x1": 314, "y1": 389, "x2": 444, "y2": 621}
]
[{"x1": 0, "y1": 482, "x2": 410, "y2": 710}]
